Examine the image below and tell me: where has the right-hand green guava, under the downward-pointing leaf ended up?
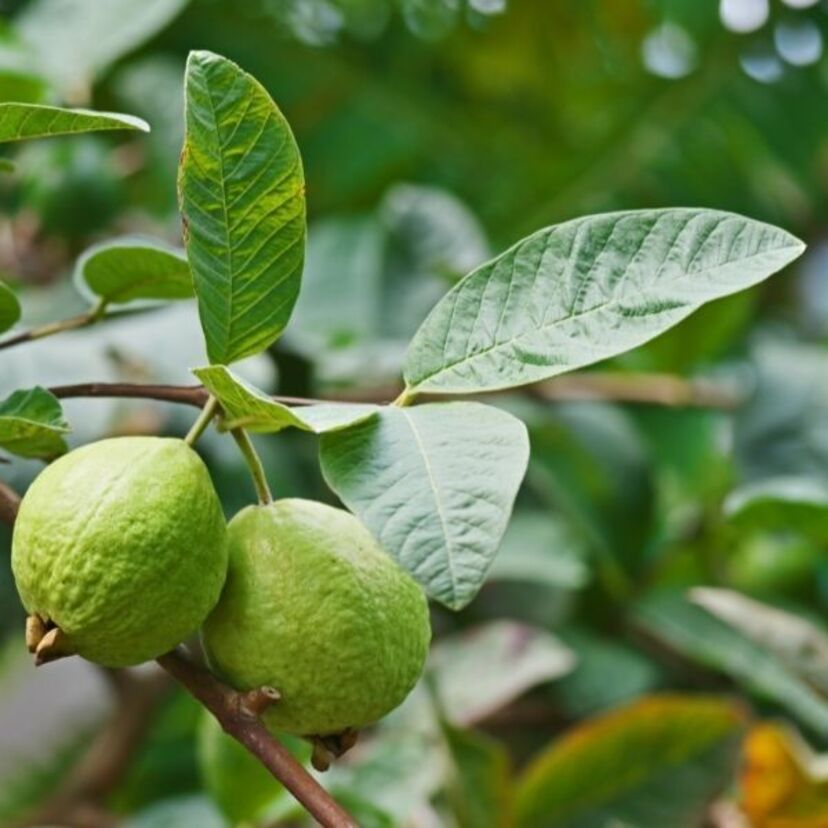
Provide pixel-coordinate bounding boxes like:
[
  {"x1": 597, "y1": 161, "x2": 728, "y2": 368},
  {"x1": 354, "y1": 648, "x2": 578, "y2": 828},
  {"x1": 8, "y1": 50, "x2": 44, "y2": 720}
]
[{"x1": 202, "y1": 499, "x2": 431, "y2": 735}]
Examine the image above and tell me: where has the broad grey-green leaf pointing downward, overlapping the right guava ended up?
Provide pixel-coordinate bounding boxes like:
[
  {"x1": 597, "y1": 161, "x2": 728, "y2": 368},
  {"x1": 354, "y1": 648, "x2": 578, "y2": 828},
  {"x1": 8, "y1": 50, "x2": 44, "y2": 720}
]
[{"x1": 322, "y1": 402, "x2": 529, "y2": 609}]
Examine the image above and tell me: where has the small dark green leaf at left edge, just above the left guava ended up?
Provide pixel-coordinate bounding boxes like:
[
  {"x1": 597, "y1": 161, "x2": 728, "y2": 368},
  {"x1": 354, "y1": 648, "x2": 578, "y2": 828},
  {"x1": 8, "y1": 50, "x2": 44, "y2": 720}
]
[{"x1": 0, "y1": 386, "x2": 70, "y2": 458}]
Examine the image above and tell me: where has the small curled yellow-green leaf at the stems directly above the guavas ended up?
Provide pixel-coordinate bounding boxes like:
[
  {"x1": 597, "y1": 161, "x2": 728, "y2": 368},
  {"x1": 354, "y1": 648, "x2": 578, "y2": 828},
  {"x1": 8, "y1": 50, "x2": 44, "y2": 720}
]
[{"x1": 193, "y1": 365, "x2": 379, "y2": 434}]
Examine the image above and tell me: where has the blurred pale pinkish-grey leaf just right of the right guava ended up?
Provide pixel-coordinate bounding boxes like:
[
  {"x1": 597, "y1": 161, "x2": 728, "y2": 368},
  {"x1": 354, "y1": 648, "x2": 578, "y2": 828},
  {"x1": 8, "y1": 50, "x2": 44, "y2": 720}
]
[{"x1": 429, "y1": 621, "x2": 575, "y2": 727}]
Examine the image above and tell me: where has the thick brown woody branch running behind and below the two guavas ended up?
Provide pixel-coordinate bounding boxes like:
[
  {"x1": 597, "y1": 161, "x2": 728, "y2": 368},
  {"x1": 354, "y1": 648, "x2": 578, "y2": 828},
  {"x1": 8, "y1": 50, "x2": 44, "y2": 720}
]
[{"x1": 0, "y1": 483, "x2": 359, "y2": 828}]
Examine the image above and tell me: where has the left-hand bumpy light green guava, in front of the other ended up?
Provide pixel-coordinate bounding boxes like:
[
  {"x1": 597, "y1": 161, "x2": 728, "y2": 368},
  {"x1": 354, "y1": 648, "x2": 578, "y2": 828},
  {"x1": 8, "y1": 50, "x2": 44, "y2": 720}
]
[{"x1": 12, "y1": 437, "x2": 227, "y2": 667}]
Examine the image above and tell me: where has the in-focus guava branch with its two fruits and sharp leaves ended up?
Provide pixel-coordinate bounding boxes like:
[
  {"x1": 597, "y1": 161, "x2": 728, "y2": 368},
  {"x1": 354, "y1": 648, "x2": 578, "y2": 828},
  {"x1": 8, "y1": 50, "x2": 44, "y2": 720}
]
[{"x1": 0, "y1": 52, "x2": 804, "y2": 826}]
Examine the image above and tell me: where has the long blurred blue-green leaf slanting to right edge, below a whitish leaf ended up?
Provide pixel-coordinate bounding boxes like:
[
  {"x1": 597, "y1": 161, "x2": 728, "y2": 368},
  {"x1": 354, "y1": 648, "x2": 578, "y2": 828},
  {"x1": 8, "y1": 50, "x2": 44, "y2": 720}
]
[{"x1": 636, "y1": 592, "x2": 828, "y2": 732}]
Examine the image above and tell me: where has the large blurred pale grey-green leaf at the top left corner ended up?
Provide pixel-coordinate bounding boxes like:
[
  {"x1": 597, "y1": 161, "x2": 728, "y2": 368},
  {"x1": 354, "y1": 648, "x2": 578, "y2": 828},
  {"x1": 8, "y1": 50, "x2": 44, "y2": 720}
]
[{"x1": 15, "y1": 0, "x2": 188, "y2": 101}]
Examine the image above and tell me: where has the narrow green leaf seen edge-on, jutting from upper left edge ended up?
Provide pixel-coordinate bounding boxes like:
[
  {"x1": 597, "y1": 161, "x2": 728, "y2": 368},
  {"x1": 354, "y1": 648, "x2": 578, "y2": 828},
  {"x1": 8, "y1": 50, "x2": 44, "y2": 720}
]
[{"x1": 0, "y1": 103, "x2": 149, "y2": 143}]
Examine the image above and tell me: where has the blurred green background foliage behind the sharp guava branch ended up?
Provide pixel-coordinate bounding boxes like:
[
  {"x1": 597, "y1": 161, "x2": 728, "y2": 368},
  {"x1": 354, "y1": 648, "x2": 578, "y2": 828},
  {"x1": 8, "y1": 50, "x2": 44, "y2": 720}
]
[{"x1": 0, "y1": 0, "x2": 828, "y2": 828}]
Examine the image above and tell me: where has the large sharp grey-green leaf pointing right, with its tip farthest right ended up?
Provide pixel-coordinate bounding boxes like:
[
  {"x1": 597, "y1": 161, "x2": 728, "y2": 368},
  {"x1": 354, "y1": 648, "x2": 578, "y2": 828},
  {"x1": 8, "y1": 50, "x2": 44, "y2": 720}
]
[{"x1": 405, "y1": 209, "x2": 805, "y2": 394}]
